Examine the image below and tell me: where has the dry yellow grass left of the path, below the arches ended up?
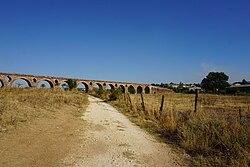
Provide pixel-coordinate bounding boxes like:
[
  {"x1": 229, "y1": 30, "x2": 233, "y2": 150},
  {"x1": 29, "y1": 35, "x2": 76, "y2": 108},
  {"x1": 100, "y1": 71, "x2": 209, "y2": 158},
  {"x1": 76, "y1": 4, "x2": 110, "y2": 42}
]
[{"x1": 0, "y1": 88, "x2": 88, "y2": 131}]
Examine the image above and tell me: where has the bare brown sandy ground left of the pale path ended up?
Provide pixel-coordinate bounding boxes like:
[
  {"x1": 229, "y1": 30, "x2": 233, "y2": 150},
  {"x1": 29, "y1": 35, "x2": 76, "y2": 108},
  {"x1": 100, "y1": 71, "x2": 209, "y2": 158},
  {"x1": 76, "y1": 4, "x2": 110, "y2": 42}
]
[{"x1": 0, "y1": 106, "x2": 86, "y2": 167}]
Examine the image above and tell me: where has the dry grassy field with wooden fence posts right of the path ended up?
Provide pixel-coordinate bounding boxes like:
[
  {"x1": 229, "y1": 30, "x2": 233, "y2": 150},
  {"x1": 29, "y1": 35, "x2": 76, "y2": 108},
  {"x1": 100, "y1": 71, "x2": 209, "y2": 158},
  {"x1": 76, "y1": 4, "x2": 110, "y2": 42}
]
[{"x1": 111, "y1": 93, "x2": 250, "y2": 166}]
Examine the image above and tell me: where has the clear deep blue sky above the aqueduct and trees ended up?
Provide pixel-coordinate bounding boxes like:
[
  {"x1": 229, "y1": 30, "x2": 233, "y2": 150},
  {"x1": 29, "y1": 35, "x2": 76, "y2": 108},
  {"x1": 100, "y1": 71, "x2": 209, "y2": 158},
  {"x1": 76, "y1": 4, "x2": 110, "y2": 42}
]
[{"x1": 0, "y1": 0, "x2": 250, "y2": 83}]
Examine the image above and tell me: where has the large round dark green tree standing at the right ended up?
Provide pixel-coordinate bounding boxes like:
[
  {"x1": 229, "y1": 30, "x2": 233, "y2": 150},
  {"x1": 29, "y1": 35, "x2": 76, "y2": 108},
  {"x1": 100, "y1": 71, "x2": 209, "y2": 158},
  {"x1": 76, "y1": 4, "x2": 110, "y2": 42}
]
[{"x1": 201, "y1": 72, "x2": 230, "y2": 93}]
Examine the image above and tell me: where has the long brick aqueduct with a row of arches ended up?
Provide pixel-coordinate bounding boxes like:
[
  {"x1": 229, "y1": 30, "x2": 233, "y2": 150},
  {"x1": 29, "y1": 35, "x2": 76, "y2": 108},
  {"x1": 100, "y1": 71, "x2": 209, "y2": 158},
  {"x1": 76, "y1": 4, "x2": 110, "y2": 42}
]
[{"x1": 0, "y1": 72, "x2": 170, "y2": 93}]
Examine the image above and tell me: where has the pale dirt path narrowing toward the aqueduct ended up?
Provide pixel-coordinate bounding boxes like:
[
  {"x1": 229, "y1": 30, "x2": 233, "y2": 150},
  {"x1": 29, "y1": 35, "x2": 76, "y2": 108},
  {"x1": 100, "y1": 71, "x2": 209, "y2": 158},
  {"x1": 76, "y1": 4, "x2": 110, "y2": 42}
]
[{"x1": 64, "y1": 96, "x2": 186, "y2": 167}]
